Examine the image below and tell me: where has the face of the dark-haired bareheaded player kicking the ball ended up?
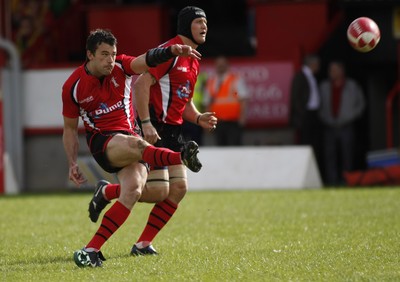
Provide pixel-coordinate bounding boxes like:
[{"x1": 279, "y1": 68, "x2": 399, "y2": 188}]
[{"x1": 89, "y1": 43, "x2": 117, "y2": 77}]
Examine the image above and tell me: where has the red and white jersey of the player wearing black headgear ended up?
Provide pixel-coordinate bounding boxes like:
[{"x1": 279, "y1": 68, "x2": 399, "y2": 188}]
[{"x1": 149, "y1": 36, "x2": 199, "y2": 125}]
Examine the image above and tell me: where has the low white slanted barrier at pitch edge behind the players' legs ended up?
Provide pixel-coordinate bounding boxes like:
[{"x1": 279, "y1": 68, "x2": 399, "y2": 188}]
[{"x1": 74, "y1": 146, "x2": 322, "y2": 190}]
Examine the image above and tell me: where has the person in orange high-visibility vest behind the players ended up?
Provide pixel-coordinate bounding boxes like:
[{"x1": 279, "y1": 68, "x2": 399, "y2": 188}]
[{"x1": 206, "y1": 56, "x2": 249, "y2": 146}]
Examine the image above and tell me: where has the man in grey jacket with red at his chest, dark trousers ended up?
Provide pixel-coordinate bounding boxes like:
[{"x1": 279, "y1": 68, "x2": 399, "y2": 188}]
[{"x1": 320, "y1": 61, "x2": 365, "y2": 186}]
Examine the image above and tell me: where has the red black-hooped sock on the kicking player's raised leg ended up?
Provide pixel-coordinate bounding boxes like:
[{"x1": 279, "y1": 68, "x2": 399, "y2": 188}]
[{"x1": 142, "y1": 146, "x2": 182, "y2": 166}]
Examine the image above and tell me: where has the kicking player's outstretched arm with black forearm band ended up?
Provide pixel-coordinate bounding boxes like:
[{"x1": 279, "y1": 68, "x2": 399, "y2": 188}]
[{"x1": 131, "y1": 44, "x2": 201, "y2": 74}]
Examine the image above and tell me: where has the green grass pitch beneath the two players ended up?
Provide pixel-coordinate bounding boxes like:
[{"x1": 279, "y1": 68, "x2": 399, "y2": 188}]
[{"x1": 0, "y1": 188, "x2": 400, "y2": 281}]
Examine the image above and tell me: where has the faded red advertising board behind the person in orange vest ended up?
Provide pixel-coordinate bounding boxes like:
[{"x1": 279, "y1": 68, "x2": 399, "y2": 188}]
[{"x1": 200, "y1": 62, "x2": 294, "y2": 128}]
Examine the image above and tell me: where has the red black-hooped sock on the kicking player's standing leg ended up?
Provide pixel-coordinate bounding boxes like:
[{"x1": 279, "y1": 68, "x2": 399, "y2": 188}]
[{"x1": 86, "y1": 201, "x2": 131, "y2": 250}]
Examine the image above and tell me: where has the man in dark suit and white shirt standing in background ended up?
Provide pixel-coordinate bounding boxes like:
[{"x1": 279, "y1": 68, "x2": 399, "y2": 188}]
[{"x1": 290, "y1": 55, "x2": 322, "y2": 175}]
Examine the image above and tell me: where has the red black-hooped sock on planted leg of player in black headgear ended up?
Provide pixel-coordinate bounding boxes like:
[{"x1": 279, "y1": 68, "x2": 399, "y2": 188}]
[{"x1": 137, "y1": 199, "x2": 178, "y2": 243}]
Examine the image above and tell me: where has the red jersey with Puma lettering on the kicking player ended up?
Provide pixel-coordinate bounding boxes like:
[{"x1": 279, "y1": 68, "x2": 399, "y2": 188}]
[{"x1": 62, "y1": 54, "x2": 135, "y2": 132}]
